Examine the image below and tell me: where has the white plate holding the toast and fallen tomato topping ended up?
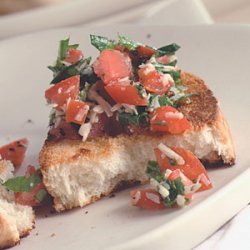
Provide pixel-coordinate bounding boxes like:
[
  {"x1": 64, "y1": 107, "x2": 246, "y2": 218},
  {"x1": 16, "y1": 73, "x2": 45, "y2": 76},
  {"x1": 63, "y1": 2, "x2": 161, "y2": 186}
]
[{"x1": 0, "y1": 26, "x2": 250, "y2": 250}]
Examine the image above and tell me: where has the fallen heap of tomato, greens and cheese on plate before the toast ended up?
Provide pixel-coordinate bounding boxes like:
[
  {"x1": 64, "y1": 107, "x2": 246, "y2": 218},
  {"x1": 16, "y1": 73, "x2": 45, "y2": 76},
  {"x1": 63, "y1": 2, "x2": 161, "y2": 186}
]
[{"x1": 130, "y1": 144, "x2": 212, "y2": 210}]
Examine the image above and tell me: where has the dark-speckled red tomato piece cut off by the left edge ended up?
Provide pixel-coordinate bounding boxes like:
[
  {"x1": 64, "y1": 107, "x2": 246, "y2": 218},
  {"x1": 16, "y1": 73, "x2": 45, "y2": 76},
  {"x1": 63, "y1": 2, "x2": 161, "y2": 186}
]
[{"x1": 0, "y1": 138, "x2": 28, "y2": 167}]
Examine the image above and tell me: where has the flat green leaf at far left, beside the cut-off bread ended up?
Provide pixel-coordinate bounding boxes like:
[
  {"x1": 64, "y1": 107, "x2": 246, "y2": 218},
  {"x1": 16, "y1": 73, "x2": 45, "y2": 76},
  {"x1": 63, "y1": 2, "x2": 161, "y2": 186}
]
[{"x1": 2, "y1": 175, "x2": 41, "y2": 192}]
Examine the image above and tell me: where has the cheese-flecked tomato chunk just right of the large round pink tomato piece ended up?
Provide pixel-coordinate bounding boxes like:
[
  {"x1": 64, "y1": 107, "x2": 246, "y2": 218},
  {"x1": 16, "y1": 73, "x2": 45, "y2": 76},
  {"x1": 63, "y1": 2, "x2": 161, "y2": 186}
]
[{"x1": 138, "y1": 68, "x2": 174, "y2": 95}]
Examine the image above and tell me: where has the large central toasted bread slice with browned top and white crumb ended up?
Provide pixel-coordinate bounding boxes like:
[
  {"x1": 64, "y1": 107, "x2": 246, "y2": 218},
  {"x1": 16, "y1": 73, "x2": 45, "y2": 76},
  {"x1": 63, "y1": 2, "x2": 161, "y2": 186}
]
[{"x1": 39, "y1": 72, "x2": 235, "y2": 211}]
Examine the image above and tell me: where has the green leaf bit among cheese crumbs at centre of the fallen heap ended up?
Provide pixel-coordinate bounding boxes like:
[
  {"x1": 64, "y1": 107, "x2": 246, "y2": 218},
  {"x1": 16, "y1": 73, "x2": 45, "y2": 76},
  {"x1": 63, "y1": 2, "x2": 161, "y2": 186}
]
[{"x1": 163, "y1": 177, "x2": 185, "y2": 207}]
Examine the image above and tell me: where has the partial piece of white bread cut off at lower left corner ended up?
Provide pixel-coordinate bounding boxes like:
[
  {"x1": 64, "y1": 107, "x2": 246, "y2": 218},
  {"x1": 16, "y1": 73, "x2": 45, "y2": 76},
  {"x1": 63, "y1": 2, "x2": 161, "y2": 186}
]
[{"x1": 0, "y1": 160, "x2": 35, "y2": 249}]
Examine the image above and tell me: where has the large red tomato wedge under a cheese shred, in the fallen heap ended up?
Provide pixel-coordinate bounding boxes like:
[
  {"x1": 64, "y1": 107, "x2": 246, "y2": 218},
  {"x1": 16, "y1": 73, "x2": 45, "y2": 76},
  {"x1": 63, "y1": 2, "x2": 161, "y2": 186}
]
[{"x1": 154, "y1": 147, "x2": 212, "y2": 191}]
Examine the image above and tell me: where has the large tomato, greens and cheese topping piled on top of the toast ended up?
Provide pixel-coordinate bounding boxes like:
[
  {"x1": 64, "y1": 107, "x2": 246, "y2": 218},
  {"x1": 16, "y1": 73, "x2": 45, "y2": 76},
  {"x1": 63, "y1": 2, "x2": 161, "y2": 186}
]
[{"x1": 45, "y1": 35, "x2": 191, "y2": 140}]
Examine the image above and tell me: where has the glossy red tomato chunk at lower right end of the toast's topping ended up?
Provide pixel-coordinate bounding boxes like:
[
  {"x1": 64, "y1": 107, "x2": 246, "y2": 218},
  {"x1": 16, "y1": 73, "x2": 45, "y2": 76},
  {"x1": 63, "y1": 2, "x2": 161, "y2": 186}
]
[{"x1": 150, "y1": 106, "x2": 190, "y2": 134}]
